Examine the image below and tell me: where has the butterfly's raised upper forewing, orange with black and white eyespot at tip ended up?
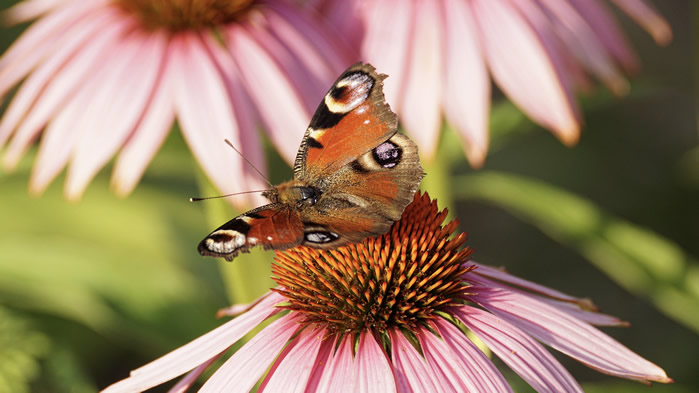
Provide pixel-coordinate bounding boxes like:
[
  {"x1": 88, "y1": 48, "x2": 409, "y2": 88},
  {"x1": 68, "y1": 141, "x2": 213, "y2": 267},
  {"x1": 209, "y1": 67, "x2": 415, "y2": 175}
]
[{"x1": 294, "y1": 63, "x2": 398, "y2": 183}]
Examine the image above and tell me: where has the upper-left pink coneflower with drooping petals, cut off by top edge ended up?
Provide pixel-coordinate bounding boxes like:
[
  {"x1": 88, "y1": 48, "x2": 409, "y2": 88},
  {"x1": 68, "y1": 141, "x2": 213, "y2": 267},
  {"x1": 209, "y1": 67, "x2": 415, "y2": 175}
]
[{"x1": 0, "y1": 0, "x2": 349, "y2": 202}]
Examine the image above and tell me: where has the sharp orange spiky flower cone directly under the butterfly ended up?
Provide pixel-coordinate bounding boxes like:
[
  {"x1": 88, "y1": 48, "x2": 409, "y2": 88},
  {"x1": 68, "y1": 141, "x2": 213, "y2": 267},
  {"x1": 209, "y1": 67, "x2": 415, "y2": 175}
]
[{"x1": 272, "y1": 193, "x2": 471, "y2": 334}]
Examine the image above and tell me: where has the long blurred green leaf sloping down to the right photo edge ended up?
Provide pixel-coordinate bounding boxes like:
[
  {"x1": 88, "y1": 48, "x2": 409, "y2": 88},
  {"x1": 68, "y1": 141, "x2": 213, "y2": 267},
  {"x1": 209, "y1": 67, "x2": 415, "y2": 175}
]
[{"x1": 455, "y1": 171, "x2": 699, "y2": 331}]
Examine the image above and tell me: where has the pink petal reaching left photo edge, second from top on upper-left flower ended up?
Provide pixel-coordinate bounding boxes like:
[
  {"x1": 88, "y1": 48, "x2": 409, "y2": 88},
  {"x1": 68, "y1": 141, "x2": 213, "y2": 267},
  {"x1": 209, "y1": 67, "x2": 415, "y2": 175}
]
[{"x1": 0, "y1": 1, "x2": 102, "y2": 96}]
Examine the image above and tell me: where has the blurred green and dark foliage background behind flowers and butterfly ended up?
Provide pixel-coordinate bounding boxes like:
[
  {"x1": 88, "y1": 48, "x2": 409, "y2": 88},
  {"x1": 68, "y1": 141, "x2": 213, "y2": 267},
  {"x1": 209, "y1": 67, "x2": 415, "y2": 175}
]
[{"x1": 0, "y1": 1, "x2": 699, "y2": 393}]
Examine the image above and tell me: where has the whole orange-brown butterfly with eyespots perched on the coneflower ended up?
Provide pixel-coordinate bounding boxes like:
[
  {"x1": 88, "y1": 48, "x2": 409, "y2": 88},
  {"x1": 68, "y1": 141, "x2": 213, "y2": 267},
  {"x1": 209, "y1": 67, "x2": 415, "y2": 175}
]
[{"x1": 198, "y1": 63, "x2": 424, "y2": 261}]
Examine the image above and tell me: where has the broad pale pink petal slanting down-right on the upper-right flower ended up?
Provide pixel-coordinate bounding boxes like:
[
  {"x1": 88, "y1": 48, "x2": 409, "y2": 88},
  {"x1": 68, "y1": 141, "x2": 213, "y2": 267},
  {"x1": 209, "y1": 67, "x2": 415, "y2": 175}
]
[{"x1": 471, "y1": 0, "x2": 580, "y2": 144}]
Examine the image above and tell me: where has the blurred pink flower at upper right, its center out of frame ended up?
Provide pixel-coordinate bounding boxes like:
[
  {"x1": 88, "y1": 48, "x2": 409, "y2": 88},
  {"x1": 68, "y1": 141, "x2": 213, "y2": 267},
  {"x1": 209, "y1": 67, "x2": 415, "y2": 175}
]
[{"x1": 316, "y1": 0, "x2": 672, "y2": 167}]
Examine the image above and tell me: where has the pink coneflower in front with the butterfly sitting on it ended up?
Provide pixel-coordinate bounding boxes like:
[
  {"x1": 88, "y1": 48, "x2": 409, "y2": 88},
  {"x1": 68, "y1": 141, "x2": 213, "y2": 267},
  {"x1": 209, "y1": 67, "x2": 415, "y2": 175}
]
[{"x1": 104, "y1": 194, "x2": 672, "y2": 393}]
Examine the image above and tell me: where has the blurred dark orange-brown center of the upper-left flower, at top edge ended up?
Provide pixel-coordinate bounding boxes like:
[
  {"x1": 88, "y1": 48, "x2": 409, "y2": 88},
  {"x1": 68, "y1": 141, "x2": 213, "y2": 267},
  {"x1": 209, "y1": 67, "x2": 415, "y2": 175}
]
[{"x1": 115, "y1": 0, "x2": 254, "y2": 31}]
